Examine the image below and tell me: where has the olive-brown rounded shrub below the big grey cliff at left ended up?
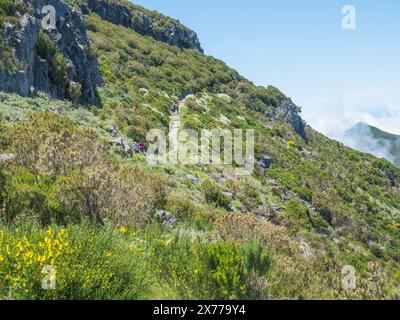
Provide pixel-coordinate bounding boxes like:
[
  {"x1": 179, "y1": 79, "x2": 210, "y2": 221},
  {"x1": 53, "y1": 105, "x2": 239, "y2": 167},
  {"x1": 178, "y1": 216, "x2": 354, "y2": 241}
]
[{"x1": 11, "y1": 113, "x2": 101, "y2": 174}]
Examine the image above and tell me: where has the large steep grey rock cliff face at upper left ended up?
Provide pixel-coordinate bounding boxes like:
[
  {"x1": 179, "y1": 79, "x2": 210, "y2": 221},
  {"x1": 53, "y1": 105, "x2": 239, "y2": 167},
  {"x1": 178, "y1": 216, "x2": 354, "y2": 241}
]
[{"x1": 0, "y1": 0, "x2": 103, "y2": 104}]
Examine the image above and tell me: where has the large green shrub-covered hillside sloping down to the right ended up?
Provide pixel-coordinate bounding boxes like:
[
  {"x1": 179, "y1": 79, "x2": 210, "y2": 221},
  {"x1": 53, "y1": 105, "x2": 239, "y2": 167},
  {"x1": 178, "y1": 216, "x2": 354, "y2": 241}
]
[{"x1": 0, "y1": 0, "x2": 400, "y2": 299}]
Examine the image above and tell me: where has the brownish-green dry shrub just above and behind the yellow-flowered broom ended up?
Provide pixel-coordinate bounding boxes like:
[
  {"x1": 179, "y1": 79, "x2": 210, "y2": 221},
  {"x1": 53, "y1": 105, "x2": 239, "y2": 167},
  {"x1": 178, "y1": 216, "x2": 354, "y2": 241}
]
[{"x1": 56, "y1": 164, "x2": 166, "y2": 227}]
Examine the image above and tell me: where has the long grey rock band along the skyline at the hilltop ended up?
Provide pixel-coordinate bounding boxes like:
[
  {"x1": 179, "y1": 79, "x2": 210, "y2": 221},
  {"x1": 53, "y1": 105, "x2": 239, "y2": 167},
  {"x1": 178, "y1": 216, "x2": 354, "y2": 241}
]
[{"x1": 80, "y1": 0, "x2": 203, "y2": 52}]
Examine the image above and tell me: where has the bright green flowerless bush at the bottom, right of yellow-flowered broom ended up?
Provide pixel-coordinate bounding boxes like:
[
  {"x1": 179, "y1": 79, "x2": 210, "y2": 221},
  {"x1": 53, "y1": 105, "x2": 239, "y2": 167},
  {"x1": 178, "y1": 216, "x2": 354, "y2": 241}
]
[{"x1": 147, "y1": 229, "x2": 270, "y2": 300}]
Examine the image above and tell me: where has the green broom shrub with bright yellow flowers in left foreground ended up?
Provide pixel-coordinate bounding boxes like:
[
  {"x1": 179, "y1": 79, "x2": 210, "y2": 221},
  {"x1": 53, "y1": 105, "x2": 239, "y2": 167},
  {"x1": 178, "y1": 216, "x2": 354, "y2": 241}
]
[{"x1": 0, "y1": 223, "x2": 151, "y2": 300}]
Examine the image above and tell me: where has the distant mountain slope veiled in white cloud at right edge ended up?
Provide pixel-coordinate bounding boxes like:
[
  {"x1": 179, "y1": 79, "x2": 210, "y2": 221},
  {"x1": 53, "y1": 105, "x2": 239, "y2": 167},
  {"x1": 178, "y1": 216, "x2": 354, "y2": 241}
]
[{"x1": 345, "y1": 123, "x2": 400, "y2": 166}]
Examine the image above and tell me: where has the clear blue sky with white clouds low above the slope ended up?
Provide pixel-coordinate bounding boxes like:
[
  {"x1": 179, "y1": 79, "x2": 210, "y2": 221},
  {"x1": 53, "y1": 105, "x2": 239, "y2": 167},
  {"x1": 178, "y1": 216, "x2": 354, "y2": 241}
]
[{"x1": 133, "y1": 0, "x2": 400, "y2": 138}]
